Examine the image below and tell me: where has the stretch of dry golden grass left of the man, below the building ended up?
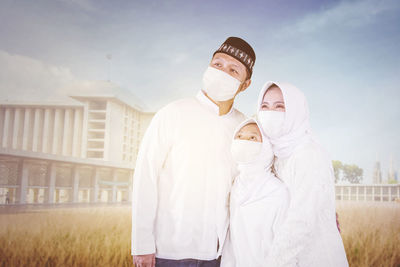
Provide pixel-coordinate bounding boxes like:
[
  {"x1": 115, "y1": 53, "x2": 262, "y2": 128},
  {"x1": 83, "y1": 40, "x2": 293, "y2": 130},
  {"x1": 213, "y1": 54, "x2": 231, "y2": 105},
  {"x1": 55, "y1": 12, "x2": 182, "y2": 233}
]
[{"x1": 0, "y1": 207, "x2": 132, "y2": 266}]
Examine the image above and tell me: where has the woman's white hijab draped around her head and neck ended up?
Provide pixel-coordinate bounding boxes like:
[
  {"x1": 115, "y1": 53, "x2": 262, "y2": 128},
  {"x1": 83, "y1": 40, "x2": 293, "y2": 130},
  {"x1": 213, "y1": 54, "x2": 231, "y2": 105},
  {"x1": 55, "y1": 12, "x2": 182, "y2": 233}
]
[{"x1": 257, "y1": 81, "x2": 313, "y2": 158}]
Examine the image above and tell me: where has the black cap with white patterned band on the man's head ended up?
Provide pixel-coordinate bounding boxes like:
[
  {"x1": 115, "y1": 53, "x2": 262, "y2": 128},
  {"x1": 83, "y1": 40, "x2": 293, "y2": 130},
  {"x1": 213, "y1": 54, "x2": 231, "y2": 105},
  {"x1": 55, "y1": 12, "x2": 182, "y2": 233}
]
[{"x1": 213, "y1": 37, "x2": 256, "y2": 78}]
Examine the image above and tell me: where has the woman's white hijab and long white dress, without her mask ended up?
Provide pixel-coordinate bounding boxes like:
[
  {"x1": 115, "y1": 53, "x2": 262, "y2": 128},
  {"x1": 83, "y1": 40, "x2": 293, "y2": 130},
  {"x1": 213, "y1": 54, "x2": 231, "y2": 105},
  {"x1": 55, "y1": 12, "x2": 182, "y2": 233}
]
[{"x1": 258, "y1": 82, "x2": 348, "y2": 267}]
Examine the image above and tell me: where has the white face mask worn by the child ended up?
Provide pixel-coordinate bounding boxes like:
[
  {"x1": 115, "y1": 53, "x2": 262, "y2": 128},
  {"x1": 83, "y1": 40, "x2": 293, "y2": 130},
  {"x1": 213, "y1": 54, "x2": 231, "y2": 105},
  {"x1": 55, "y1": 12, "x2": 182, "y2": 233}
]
[{"x1": 231, "y1": 139, "x2": 262, "y2": 163}]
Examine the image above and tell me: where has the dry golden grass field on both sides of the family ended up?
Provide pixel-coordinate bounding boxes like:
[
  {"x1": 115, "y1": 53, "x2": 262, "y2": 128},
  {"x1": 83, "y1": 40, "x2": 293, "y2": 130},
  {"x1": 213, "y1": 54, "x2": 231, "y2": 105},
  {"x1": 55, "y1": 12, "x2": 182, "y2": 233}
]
[{"x1": 0, "y1": 203, "x2": 400, "y2": 267}]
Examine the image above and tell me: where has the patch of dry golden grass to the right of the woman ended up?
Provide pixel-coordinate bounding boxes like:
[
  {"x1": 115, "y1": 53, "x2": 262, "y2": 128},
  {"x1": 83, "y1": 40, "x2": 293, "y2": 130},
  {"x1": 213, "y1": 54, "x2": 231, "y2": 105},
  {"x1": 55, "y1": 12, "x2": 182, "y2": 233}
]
[{"x1": 337, "y1": 202, "x2": 400, "y2": 267}]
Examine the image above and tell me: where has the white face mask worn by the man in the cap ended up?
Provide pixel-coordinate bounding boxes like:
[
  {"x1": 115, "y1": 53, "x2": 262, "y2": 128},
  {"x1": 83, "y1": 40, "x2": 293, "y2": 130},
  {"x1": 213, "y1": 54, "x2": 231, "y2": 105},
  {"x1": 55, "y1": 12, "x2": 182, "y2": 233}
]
[{"x1": 203, "y1": 67, "x2": 241, "y2": 101}]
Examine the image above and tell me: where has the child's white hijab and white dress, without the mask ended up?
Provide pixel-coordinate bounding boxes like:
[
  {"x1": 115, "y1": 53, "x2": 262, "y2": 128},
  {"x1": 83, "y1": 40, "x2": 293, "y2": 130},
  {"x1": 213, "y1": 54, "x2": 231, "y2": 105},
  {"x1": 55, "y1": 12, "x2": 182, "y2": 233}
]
[{"x1": 221, "y1": 119, "x2": 289, "y2": 267}]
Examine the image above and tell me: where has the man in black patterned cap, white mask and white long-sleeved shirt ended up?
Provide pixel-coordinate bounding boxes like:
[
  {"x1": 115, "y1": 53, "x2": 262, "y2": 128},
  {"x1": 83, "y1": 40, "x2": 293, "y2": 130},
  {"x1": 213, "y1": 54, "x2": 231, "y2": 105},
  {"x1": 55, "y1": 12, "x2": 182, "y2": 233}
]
[{"x1": 132, "y1": 37, "x2": 255, "y2": 267}]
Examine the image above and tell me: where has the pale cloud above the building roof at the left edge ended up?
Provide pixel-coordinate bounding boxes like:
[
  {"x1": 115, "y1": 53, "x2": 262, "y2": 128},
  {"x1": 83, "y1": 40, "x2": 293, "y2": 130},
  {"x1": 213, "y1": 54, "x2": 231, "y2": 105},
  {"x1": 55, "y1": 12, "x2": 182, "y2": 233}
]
[{"x1": 0, "y1": 50, "x2": 77, "y2": 102}]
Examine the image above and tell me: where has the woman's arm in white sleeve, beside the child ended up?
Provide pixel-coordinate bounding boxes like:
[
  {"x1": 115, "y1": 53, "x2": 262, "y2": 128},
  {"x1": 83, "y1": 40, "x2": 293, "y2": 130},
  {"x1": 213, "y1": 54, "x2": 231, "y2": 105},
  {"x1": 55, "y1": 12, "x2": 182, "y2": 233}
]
[{"x1": 265, "y1": 150, "x2": 330, "y2": 267}]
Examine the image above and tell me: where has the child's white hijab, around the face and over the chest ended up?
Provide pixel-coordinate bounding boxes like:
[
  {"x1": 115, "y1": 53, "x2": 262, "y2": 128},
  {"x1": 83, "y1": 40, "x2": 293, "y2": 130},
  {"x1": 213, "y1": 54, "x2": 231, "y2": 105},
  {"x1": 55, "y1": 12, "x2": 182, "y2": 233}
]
[{"x1": 233, "y1": 119, "x2": 277, "y2": 204}]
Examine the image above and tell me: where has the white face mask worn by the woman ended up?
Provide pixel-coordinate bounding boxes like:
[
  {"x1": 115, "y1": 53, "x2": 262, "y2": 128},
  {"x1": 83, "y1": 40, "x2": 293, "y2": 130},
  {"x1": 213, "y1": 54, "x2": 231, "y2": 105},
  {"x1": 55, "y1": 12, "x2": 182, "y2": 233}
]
[{"x1": 258, "y1": 110, "x2": 285, "y2": 138}]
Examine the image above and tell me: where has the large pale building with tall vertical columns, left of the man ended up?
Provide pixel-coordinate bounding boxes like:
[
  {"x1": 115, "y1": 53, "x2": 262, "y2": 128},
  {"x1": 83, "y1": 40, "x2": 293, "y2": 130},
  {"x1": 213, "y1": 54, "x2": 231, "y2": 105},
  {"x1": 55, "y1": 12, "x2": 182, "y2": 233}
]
[{"x1": 0, "y1": 84, "x2": 154, "y2": 204}]
